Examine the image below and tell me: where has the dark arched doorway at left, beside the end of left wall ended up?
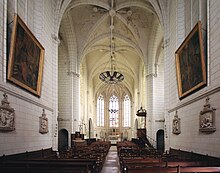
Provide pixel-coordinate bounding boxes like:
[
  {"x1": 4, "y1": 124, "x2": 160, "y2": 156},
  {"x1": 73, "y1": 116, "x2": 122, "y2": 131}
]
[{"x1": 58, "y1": 129, "x2": 68, "y2": 151}]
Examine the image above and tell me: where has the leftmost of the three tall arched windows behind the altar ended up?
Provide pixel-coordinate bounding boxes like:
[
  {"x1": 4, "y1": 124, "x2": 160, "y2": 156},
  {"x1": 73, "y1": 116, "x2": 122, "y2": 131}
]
[{"x1": 97, "y1": 95, "x2": 104, "y2": 126}]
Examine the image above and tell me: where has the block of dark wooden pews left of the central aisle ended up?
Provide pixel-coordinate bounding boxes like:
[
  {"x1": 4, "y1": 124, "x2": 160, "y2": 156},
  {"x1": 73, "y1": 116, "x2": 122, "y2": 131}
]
[{"x1": 0, "y1": 141, "x2": 110, "y2": 173}]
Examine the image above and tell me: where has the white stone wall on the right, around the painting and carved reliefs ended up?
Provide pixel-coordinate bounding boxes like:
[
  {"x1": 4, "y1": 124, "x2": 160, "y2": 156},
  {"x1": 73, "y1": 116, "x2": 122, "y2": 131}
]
[{"x1": 165, "y1": 0, "x2": 220, "y2": 157}]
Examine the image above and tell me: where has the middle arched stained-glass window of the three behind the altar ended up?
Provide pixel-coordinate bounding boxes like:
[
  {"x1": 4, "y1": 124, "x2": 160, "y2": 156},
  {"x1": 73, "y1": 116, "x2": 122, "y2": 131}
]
[{"x1": 109, "y1": 95, "x2": 119, "y2": 127}]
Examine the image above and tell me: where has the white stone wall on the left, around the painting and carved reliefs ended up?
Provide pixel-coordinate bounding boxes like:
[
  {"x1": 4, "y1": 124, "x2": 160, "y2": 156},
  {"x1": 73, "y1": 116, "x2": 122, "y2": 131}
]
[{"x1": 0, "y1": 0, "x2": 57, "y2": 155}]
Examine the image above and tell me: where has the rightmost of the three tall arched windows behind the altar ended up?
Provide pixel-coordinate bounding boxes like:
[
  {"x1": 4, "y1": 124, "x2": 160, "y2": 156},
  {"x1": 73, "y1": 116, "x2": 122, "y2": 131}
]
[{"x1": 124, "y1": 95, "x2": 131, "y2": 127}]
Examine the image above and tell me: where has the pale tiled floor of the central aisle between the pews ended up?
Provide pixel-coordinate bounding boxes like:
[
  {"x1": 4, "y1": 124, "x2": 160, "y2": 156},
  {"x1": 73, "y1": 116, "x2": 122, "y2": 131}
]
[{"x1": 101, "y1": 146, "x2": 120, "y2": 173}]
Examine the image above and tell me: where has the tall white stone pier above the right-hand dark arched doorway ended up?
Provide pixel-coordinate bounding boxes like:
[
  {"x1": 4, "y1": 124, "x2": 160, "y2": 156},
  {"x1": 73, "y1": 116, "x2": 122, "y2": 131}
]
[{"x1": 146, "y1": 17, "x2": 164, "y2": 142}]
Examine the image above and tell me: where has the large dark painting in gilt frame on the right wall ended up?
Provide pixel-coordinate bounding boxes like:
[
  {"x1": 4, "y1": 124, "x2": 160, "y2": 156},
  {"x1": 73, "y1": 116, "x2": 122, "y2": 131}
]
[{"x1": 175, "y1": 21, "x2": 206, "y2": 99}]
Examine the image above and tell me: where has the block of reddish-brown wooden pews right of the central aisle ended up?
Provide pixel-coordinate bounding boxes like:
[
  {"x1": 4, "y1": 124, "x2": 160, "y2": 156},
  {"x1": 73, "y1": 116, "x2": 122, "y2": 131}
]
[{"x1": 117, "y1": 141, "x2": 220, "y2": 173}]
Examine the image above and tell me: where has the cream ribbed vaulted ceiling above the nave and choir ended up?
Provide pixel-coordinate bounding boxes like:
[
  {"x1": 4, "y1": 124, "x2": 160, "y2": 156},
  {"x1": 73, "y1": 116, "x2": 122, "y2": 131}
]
[{"x1": 59, "y1": 0, "x2": 163, "y2": 97}]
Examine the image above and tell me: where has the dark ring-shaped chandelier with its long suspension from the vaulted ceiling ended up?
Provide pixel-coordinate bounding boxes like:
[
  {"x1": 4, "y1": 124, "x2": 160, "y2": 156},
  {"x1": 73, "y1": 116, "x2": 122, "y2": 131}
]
[{"x1": 99, "y1": 5, "x2": 124, "y2": 84}]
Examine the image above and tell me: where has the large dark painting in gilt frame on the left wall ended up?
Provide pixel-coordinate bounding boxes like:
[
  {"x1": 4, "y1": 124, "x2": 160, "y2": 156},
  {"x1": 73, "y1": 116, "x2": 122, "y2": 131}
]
[{"x1": 7, "y1": 15, "x2": 44, "y2": 97}]
